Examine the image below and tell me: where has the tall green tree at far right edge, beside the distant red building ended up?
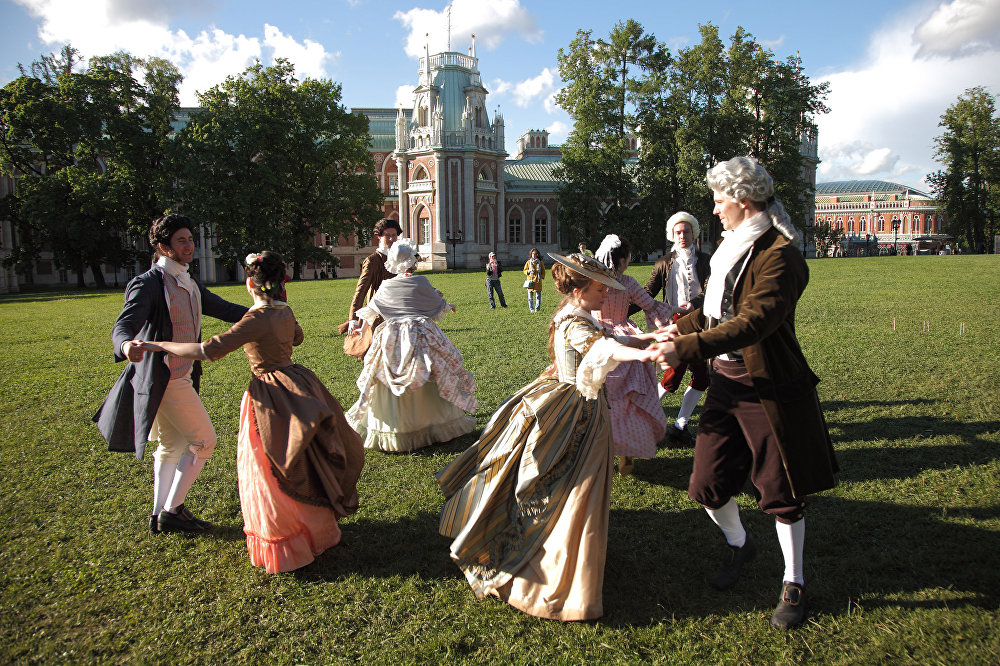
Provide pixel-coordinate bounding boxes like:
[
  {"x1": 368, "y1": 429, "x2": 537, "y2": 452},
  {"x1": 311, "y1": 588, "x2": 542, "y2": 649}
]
[{"x1": 927, "y1": 86, "x2": 1000, "y2": 252}]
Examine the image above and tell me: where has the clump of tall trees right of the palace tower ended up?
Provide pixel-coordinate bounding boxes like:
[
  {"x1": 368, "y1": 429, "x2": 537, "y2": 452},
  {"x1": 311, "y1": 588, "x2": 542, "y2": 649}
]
[{"x1": 556, "y1": 19, "x2": 828, "y2": 254}]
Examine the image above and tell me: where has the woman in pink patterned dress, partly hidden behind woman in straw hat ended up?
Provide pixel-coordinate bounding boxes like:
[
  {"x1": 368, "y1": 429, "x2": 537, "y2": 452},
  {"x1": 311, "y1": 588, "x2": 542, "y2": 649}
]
[{"x1": 591, "y1": 234, "x2": 670, "y2": 476}]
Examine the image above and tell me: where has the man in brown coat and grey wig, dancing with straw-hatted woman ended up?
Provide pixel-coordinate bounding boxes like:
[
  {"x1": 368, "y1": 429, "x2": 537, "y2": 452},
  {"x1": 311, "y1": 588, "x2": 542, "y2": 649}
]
[{"x1": 660, "y1": 157, "x2": 837, "y2": 629}]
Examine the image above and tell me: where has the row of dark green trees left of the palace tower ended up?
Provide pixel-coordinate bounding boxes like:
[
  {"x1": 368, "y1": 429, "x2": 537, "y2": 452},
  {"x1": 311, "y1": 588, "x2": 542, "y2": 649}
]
[{"x1": 0, "y1": 46, "x2": 383, "y2": 286}]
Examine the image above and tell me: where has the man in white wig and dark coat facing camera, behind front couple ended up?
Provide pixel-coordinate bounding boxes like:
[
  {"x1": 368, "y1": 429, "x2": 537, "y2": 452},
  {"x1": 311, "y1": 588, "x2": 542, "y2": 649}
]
[{"x1": 629, "y1": 211, "x2": 711, "y2": 446}]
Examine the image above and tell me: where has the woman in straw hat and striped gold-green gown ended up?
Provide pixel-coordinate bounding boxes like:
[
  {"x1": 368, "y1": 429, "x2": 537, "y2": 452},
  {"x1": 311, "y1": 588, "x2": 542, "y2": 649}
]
[{"x1": 437, "y1": 253, "x2": 654, "y2": 620}]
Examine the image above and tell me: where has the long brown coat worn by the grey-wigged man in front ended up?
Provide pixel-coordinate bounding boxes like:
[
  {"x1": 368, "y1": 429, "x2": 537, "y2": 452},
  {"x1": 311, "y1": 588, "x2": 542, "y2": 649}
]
[{"x1": 674, "y1": 227, "x2": 837, "y2": 497}]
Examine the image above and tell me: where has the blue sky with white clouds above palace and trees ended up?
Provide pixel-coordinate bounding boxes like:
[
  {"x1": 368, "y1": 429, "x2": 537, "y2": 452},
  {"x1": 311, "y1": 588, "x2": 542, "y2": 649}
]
[{"x1": 0, "y1": 0, "x2": 1000, "y2": 187}]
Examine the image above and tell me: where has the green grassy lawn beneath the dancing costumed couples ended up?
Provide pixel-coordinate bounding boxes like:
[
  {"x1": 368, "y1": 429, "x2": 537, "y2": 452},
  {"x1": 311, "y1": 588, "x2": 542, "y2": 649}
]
[{"x1": 0, "y1": 256, "x2": 1000, "y2": 664}]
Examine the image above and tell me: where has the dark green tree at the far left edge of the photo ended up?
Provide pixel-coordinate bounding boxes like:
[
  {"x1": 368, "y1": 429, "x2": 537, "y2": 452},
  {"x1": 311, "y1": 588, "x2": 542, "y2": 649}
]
[{"x1": 0, "y1": 46, "x2": 180, "y2": 287}]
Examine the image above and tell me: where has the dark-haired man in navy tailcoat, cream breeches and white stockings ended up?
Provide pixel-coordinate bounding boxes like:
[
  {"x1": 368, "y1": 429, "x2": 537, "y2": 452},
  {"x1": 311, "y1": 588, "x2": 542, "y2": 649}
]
[{"x1": 94, "y1": 214, "x2": 247, "y2": 533}]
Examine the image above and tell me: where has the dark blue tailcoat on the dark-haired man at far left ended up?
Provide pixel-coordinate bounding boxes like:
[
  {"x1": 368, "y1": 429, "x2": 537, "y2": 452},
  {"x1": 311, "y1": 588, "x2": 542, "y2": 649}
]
[{"x1": 93, "y1": 266, "x2": 247, "y2": 459}]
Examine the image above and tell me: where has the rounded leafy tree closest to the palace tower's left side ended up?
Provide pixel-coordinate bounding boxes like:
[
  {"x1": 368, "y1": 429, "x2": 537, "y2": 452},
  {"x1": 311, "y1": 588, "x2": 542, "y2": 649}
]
[{"x1": 177, "y1": 59, "x2": 383, "y2": 277}]
